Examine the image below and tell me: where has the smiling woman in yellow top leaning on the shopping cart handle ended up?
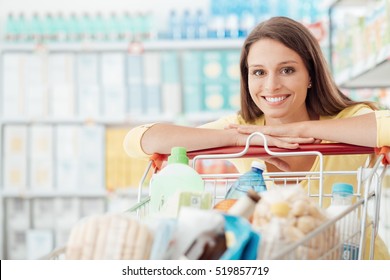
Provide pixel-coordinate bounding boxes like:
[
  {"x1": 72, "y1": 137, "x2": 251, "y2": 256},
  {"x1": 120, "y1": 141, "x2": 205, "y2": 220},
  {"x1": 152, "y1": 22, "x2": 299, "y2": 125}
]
[{"x1": 124, "y1": 17, "x2": 390, "y2": 259}]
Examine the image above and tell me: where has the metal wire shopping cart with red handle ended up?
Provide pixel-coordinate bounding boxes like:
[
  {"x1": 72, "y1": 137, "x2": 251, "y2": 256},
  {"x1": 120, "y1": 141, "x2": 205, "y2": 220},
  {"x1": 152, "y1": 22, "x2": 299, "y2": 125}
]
[{"x1": 129, "y1": 132, "x2": 386, "y2": 259}]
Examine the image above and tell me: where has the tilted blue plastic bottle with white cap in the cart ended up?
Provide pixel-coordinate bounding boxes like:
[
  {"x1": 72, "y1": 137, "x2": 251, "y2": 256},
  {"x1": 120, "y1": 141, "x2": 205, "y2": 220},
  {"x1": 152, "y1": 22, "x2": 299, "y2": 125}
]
[{"x1": 225, "y1": 161, "x2": 267, "y2": 199}]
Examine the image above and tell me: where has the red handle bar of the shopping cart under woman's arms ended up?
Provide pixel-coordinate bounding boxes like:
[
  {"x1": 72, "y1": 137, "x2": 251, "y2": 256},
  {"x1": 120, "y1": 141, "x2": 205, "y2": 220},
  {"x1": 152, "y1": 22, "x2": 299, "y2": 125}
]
[{"x1": 150, "y1": 143, "x2": 374, "y2": 170}]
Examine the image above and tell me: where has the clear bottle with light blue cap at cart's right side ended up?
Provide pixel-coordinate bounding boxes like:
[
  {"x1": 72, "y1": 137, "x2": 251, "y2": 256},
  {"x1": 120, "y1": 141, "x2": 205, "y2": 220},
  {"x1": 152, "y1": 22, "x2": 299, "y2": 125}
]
[{"x1": 326, "y1": 183, "x2": 359, "y2": 260}]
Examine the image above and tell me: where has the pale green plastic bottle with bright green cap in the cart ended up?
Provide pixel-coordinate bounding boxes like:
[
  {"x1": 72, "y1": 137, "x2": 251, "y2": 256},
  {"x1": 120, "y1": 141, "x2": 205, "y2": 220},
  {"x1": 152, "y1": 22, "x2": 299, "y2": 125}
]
[{"x1": 150, "y1": 147, "x2": 204, "y2": 212}]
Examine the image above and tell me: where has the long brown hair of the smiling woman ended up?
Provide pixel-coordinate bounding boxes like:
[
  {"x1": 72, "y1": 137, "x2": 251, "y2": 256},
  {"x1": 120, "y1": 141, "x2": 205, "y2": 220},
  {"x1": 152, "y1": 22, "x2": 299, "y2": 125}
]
[{"x1": 240, "y1": 17, "x2": 375, "y2": 123}]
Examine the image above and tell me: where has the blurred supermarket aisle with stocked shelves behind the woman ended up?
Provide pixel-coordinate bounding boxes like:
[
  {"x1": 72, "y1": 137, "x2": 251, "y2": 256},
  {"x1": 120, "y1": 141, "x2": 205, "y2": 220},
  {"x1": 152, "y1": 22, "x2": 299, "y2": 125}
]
[{"x1": 0, "y1": 0, "x2": 390, "y2": 259}]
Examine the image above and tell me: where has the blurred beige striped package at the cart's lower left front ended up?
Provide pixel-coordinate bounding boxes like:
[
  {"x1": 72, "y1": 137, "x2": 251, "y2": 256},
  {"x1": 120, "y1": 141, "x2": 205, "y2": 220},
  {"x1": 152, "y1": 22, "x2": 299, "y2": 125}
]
[{"x1": 65, "y1": 214, "x2": 153, "y2": 260}]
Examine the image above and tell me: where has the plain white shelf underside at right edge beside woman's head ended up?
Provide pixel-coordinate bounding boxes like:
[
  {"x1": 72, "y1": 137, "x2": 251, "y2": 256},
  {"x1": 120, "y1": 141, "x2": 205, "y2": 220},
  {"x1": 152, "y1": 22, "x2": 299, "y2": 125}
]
[{"x1": 336, "y1": 46, "x2": 390, "y2": 88}]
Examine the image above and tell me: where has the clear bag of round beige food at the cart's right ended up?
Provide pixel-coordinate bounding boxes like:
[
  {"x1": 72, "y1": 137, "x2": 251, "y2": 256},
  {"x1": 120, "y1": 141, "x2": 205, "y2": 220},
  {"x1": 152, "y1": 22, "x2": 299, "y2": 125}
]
[{"x1": 252, "y1": 186, "x2": 338, "y2": 259}]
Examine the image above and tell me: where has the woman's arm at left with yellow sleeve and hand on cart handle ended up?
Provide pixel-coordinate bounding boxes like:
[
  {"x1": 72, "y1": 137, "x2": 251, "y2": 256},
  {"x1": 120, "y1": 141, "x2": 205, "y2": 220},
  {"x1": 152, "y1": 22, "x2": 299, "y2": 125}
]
[{"x1": 123, "y1": 123, "x2": 314, "y2": 158}]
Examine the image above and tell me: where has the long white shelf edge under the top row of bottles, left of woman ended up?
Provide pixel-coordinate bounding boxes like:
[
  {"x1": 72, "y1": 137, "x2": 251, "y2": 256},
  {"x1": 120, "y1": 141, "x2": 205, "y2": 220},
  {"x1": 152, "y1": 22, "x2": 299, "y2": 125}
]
[{"x1": 0, "y1": 39, "x2": 244, "y2": 53}]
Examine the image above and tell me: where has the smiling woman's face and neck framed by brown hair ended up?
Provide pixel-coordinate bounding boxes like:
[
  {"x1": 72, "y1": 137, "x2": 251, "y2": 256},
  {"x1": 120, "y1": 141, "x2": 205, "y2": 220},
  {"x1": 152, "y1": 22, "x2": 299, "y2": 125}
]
[{"x1": 247, "y1": 39, "x2": 310, "y2": 124}]
